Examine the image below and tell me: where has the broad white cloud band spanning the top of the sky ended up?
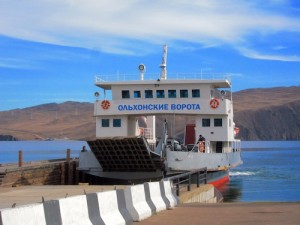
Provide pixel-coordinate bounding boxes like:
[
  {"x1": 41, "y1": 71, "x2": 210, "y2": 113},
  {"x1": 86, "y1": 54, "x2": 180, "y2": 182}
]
[{"x1": 0, "y1": 0, "x2": 300, "y2": 54}]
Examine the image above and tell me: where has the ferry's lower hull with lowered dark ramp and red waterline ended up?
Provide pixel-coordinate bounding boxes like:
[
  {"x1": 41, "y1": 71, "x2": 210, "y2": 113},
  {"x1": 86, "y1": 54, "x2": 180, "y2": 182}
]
[{"x1": 78, "y1": 137, "x2": 242, "y2": 186}]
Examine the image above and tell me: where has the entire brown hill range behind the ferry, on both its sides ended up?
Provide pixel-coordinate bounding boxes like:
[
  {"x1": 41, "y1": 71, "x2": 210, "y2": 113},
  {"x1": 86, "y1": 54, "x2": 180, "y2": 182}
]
[{"x1": 0, "y1": 86, "x2": 300, "y2": 140}]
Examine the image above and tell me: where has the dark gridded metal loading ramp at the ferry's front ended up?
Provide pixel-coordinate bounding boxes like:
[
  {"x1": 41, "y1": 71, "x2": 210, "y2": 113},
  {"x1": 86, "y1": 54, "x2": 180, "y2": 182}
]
[{"x1": 87, "y1": 136, "x2": 161, "y2": 172}]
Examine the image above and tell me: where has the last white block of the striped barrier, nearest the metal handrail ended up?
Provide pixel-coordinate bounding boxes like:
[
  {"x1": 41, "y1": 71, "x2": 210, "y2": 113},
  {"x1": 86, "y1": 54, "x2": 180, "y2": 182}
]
[{"x1": 159, "y1": 180, "x2": 179, "y2": 209}]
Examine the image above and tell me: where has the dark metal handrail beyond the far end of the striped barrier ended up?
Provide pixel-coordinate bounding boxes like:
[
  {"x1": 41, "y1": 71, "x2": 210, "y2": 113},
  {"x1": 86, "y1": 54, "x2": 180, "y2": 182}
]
[{"x1": 164, "y1": 167, "x2": 207, "y2": 196}]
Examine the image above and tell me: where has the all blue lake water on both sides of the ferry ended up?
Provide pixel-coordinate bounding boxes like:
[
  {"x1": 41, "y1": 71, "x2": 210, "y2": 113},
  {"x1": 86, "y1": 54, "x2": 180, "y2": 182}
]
[{"x1": 0, "y1": 140, "x2": 300, "y2": 202}]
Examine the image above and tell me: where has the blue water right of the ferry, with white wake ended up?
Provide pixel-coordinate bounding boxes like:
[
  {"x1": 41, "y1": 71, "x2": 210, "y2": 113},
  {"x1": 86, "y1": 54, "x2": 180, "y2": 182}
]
[{"x1": 222, "y1": 141, "x2": 300, "y2": 202}]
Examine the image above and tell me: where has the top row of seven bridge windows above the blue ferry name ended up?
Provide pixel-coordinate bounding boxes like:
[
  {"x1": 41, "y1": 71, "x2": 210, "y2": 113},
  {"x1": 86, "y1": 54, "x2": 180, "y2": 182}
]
[{"x1": 122, "y1": 89, "x2": 200, "y2": 98}]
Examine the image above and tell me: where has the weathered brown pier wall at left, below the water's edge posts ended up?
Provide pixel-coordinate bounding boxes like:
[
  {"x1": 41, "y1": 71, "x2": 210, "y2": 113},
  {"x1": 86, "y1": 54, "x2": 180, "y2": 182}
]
[{"x1": 0, "y1": 160, "x2": 79, "y2": 187}]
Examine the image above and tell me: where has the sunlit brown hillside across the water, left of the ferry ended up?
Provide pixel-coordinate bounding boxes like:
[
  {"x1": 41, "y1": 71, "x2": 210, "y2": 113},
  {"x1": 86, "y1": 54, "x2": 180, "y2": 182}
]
[{"x1": 0, "y1": 102, "x2": 95, "y2": 139}]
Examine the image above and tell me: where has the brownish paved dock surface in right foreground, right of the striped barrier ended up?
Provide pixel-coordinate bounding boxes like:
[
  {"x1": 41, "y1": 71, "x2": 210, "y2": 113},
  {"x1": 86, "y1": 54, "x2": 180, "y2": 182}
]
[{"x1": 134, "y1": 202, "x2": 300, "y2": 225}]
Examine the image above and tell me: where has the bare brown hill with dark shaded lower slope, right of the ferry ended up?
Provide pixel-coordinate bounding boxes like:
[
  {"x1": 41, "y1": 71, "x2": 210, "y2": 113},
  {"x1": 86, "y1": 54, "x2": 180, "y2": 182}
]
[{"x1": 233, "y1": 86, "x2": 300, "y2": 140}]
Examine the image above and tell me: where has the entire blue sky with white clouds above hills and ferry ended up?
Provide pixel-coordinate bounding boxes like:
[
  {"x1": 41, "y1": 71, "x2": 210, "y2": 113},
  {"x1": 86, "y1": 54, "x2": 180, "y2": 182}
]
[{"x1": 0, "y1": 0, "x2": 300, "y2": 111}]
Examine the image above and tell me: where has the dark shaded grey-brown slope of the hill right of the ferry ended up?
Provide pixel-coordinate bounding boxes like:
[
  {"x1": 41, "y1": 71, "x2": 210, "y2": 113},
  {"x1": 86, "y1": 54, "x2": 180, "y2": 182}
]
[{"x1": 235, "y1": 100, "x2": 300, "y2": 140}]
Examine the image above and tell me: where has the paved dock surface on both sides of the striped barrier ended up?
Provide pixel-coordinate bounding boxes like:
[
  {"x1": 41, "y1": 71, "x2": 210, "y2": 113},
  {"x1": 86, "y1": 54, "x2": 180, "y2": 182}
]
[{"x1": 0, "y1": 185, "x2": 300, "y2": 225}]
